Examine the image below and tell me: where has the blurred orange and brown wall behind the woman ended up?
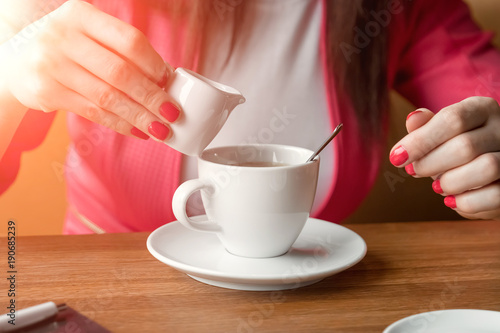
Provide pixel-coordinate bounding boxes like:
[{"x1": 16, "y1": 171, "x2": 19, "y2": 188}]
[{"x1": 0, "y1": 0, "x2": 500, "y2": 236}]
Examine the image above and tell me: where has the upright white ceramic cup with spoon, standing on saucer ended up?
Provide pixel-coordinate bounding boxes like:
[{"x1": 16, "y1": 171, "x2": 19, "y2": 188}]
[{"x1": 172, "y1": 145, "x2": 319, "y2": 258}]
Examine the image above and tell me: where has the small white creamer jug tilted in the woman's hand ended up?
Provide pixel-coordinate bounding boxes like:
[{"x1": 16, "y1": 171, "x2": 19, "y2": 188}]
[{"x1": 165, "y1": 68, "x2": 245, "y2": 156}]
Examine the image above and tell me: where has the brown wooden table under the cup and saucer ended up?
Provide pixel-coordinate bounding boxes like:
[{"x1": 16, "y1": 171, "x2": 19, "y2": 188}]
[{"x1": 4, "y1": 221, "x2": 500, "y2": 333}]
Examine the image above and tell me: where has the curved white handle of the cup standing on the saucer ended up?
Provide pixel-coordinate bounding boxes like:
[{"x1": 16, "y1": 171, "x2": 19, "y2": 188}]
[{"x1": 172, "y1": 179, "x2": 222, "y2": 232}]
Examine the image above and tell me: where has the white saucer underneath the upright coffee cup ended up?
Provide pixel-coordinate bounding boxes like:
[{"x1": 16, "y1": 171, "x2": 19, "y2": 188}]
[{"x1": 147, "y1": 218, "x2": 366, "y2": 290}]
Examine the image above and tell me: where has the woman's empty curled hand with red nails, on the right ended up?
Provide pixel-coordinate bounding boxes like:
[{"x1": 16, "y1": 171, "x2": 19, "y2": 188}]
[{"x1": 390, "y1": 97, "x2": 500, "y2": 219}]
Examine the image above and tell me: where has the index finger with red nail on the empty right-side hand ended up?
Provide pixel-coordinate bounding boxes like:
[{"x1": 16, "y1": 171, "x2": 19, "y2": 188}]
[{"x1": 390, "y1": 97, "x2": 499, "y2": 166}]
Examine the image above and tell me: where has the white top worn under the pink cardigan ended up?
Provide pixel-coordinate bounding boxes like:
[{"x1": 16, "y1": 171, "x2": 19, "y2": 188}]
[{"x1": 182, "y1": 0, "x2": 334, "y2": 214}]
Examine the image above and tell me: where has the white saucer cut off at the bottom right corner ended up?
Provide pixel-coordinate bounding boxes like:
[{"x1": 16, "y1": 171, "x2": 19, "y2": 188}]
[{"x1": 383, "y1": 309, "x2": 500, "y2": 333}]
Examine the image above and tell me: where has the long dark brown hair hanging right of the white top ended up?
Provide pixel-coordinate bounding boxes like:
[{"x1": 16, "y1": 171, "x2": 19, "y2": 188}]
[{"x1": 326, "y1": 0, "x2": 389, "y2": 139}]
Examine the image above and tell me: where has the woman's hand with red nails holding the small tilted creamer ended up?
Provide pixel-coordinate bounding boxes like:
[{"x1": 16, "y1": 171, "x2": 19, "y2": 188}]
[{"x1": 0, "y1": 0, "x2": 180, "y2": 141}]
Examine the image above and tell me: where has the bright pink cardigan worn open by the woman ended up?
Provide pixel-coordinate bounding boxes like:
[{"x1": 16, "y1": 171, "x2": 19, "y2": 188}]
[{"x1": 0, "y1": 0, "x2": 500, "y2": 233}]
